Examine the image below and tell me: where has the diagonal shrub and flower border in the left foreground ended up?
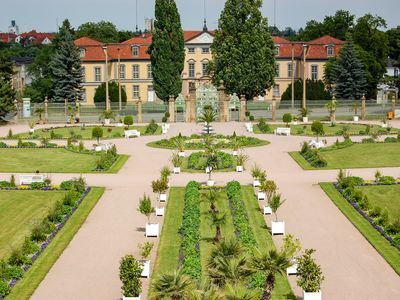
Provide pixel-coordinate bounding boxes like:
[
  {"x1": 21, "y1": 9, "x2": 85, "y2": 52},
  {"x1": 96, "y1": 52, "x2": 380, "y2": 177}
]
[{"x1": 0, "y1": 178, "x2": 90, "y2": 299}]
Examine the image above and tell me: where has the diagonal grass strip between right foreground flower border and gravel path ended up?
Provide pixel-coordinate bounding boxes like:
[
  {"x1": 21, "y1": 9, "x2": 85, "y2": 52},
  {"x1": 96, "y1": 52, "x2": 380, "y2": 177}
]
[{"x1": 320, "y1": 183, "x2": 400, "y2": 275}]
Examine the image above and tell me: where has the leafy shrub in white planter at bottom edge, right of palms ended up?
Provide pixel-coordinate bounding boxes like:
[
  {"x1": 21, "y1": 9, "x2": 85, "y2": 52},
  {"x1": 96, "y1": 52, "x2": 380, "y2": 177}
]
[{"x1": 297, "y1": 249, "x2": 325, "y2": 300}]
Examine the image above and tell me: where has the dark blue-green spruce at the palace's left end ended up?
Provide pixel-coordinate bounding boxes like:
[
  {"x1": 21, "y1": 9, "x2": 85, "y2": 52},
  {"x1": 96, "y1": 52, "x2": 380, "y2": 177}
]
[{"x1": 51, "y1": 20, "x2": 83, "y2": 102}]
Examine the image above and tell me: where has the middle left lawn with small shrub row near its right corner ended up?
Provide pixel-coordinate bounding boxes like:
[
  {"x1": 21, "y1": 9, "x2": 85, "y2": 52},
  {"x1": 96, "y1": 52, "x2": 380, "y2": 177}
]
[{"x1": 0, "y1": 148, "x2": 128, "y2": 173}]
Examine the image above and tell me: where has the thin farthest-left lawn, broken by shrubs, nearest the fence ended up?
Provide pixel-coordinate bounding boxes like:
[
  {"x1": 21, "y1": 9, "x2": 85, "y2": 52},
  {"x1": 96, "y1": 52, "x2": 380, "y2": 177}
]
[{"x1": 13, "y1": 126, "x2": 161, "y2": 140}]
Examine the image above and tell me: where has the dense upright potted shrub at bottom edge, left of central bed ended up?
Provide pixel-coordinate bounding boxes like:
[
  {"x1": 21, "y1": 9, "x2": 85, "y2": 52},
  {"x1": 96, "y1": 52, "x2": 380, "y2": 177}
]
[{"x1": 119, "y1": 255, "x2": 143, "y2": 300}]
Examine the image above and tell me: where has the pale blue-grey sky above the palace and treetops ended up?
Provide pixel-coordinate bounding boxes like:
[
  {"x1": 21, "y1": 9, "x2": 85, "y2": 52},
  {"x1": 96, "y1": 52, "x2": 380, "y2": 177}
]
[{"x1": 0, "y1": 0, "x2": 400, "y2": 32}]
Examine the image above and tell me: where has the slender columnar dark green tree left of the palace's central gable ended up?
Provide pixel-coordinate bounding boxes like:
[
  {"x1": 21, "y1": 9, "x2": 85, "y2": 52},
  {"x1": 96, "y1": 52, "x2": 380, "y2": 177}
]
[{"x1": 148, "y1": 0, "x2": 185, "y2": 101}]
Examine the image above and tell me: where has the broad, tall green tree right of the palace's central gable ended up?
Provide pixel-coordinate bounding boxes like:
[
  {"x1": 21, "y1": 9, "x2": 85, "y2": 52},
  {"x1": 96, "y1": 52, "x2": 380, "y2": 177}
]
[{"x1": 210, "y1": 0, "x2": 275, "y2": 99}]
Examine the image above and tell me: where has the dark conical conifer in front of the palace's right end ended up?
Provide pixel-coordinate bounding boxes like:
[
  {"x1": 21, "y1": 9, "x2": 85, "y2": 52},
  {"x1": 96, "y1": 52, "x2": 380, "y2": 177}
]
[{"x1": 330, "y1": 41, "x2": 367, "y2": 99}]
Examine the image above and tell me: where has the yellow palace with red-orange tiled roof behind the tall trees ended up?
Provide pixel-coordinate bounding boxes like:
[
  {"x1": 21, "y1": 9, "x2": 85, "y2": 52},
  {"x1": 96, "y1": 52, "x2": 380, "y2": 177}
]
[{"x1": 75, "y1": 27, "x2": 344, "y2": 105}]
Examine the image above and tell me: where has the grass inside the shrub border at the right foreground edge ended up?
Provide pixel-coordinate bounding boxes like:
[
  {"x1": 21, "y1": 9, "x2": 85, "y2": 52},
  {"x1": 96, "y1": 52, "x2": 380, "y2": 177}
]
[{"x1": 356, "y1": 185, "x2": 400, "y2": 222}]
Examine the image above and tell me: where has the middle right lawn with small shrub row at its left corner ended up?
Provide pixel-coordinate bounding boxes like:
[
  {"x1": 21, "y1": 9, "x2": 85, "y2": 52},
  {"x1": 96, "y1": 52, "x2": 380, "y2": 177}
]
[{"x1": 291, "y1": 143, "x2": 400, "y2": 170}]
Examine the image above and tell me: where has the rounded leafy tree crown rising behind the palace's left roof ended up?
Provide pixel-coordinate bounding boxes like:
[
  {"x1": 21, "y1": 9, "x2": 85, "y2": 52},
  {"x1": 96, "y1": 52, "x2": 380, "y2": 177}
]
[{"x1": 76, "y1": 21, "x2": 119, "y2": 43}]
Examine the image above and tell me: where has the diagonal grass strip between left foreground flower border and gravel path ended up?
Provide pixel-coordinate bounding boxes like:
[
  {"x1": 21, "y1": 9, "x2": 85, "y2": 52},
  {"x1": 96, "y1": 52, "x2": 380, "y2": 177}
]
[{"x1": 7, "y1": 187, "x2": 104, "y2": 300}]
